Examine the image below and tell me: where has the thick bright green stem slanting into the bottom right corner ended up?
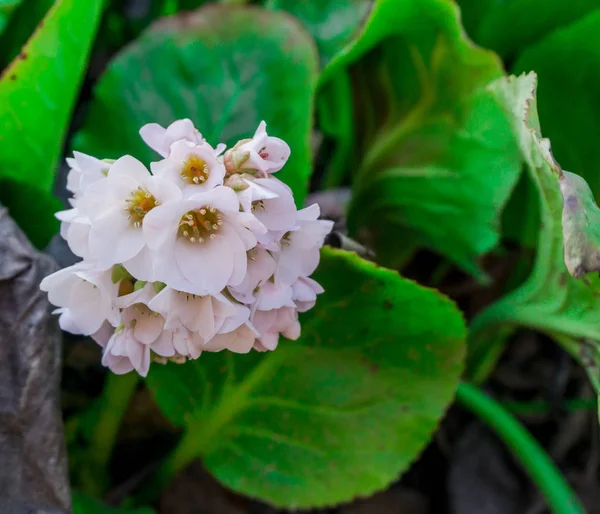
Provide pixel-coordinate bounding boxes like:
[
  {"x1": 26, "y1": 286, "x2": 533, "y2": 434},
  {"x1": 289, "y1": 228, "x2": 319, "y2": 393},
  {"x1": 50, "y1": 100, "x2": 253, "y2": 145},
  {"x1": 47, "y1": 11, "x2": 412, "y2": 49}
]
[{"x1": 456, "y1": 382, "x2": 585, "y2": 514}]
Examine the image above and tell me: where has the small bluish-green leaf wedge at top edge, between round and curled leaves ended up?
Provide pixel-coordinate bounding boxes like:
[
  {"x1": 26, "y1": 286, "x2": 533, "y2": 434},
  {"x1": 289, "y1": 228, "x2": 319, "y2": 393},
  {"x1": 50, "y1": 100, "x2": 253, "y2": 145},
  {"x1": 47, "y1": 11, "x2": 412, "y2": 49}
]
[{"x1": 265, "y1": 0, "x2": 374, "y2": 67}]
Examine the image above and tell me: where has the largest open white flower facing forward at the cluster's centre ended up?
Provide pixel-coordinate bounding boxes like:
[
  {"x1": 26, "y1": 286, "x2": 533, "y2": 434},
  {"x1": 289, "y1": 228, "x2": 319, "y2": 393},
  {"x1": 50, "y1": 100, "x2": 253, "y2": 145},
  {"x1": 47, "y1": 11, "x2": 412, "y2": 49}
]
[{"x1": 143, "y1": 186, "x2": 266, "y2": 296}]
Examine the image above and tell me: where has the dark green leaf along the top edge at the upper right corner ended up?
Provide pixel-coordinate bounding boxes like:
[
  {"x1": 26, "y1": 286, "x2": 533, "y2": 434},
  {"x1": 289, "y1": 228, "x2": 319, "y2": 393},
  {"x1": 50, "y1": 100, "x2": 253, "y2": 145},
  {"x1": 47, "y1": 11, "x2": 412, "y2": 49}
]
[{"x1": 458, "y1": 0, "x2": 599, "y2": 60}]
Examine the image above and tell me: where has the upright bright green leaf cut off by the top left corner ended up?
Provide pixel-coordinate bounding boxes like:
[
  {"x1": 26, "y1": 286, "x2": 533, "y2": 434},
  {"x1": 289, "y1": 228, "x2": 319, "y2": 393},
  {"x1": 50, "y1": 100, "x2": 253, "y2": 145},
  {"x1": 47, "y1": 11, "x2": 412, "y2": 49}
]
[{"x1": 0, "y1": 0, "x2": 102, "y2": 246}]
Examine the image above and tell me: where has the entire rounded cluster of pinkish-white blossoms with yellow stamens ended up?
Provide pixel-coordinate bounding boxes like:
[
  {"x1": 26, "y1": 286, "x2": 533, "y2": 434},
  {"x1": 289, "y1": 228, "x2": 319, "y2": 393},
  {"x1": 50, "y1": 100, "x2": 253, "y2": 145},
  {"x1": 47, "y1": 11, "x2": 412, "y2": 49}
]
[{"x1": 40, "y1": 119, "x2": 332, "y2": 376}]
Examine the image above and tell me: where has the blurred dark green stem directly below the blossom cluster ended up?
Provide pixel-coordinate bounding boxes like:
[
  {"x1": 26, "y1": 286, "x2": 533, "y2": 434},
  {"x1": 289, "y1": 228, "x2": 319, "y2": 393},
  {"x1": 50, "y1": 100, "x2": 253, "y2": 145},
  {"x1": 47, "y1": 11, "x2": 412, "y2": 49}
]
[{"x1": 81, "y1": 372, "x2": 139, "y2": 497}]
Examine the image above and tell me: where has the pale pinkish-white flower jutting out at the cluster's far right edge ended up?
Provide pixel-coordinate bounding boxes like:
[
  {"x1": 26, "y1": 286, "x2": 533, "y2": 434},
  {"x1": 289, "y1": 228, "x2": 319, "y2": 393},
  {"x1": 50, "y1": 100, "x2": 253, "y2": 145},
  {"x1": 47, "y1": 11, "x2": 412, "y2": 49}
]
[{"x1": 275, "y1": 204, "x2": 333, "y2": 285}]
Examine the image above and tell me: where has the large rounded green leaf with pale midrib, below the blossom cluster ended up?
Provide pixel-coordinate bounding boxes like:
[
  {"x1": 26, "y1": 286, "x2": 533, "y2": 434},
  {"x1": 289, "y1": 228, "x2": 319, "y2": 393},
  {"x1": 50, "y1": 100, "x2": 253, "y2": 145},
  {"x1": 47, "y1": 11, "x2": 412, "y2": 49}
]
[{"x1": 147, "y1": 249, "x2": 465, "y2": 507}]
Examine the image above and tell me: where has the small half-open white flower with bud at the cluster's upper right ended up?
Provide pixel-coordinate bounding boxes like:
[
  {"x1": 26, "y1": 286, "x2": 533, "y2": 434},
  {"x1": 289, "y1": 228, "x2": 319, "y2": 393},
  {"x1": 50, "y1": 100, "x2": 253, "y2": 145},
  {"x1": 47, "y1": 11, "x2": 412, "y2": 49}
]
[{"x1": 225, "y1": 121, "x2": 290, "y2": 173}]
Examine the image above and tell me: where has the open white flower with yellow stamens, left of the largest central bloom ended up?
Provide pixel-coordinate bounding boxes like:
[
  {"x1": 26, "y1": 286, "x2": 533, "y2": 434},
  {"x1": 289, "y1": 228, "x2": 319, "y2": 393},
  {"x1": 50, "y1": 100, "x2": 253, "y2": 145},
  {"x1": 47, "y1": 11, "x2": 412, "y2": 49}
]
[{"x1": 82, "y1": 155, "x2": 181, "y2": 280}]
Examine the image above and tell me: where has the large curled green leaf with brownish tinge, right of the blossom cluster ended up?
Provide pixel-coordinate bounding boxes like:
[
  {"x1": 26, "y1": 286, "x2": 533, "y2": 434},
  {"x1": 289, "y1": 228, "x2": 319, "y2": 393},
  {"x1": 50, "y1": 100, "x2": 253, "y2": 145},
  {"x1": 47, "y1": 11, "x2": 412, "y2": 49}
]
[{"x1": 342, "y1": 0, "x2": 521, "y2": 277}]
